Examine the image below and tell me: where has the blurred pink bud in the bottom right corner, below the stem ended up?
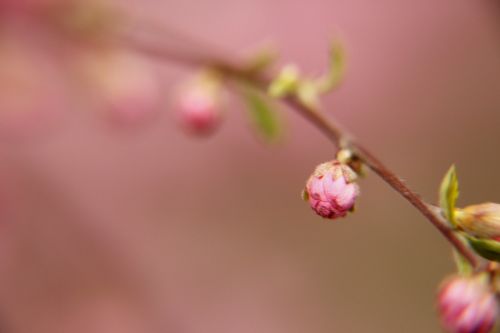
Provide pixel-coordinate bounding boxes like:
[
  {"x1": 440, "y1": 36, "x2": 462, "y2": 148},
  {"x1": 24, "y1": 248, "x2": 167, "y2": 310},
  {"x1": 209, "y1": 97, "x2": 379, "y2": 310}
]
[{"x1": 438, "y1": 274, "x2": 498, "y2": 333}]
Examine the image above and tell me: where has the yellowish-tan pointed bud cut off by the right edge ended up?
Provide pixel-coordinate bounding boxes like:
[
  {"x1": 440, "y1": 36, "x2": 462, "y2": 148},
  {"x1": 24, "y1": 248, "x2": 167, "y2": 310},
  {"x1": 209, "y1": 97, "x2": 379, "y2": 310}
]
[{"x1": 455, "y1": 202, "x2": 500, "y2": 239}]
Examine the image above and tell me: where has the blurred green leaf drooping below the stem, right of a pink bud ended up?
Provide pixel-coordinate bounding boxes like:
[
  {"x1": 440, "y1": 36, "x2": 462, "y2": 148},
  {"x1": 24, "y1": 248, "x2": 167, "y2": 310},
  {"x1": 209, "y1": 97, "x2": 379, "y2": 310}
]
[{"x1": 244, "y1": 87, "x2": 282, "y2": 142}]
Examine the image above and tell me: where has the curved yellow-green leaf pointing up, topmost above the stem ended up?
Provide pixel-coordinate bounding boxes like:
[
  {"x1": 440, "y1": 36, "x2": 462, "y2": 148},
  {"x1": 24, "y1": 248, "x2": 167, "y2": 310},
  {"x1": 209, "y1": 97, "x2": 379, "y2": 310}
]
[{"x1": 318, "y1": 41, "x2": 347, "y2": 93}]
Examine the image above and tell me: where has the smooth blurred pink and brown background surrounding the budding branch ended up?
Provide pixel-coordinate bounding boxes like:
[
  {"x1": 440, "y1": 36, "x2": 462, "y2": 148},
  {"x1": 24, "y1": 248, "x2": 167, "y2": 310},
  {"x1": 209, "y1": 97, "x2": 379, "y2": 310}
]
[{"x1": 0, "y1": 0, "x2": 500, "y2": 333}]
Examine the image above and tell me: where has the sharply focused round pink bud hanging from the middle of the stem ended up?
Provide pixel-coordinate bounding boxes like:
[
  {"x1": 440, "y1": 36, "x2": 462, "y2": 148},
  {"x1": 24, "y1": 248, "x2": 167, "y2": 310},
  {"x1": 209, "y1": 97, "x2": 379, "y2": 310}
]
[{"x1": 303, "y1": 161, "x2": 359, "y2": 219}]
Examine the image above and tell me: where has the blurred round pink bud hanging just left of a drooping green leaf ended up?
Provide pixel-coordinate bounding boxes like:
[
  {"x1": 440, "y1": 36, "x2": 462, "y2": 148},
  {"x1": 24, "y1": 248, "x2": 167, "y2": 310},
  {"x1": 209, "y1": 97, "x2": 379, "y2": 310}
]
[{"x1": 176, "y1": 75, "x2": 223, "y2": 135}]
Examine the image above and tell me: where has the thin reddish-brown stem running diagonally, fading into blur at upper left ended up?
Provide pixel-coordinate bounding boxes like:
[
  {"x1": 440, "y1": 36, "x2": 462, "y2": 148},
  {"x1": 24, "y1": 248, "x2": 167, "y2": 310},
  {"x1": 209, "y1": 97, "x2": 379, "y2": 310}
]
[{"x1": 117, "y1": 19, "x2": 479, "y2": 268}]
